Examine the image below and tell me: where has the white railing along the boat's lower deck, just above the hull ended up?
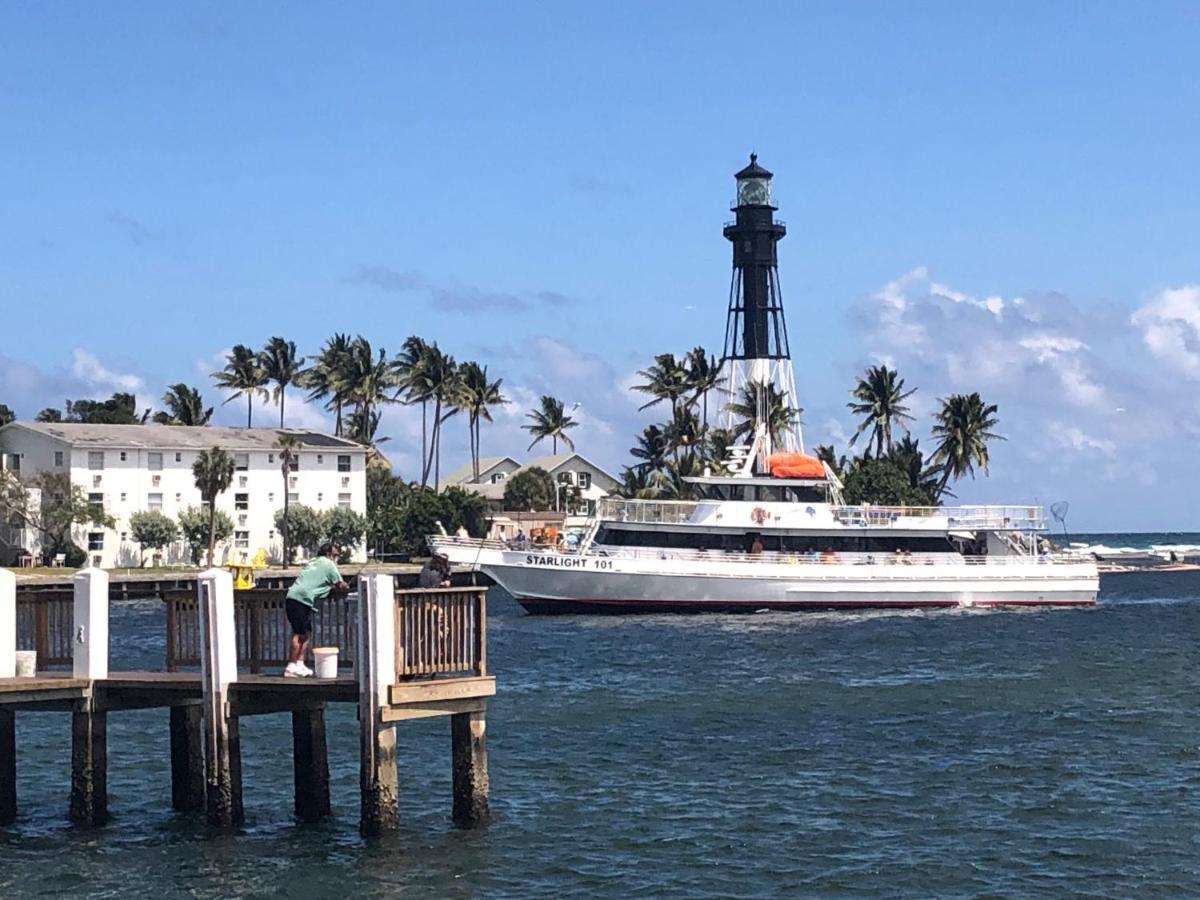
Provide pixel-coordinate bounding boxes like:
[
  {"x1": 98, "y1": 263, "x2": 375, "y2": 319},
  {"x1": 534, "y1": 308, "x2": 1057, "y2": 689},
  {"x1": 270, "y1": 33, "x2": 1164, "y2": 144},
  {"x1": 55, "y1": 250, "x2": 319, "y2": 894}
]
[{"x1": 432, "y1": 535, "x2": 1091, "y2": 565}]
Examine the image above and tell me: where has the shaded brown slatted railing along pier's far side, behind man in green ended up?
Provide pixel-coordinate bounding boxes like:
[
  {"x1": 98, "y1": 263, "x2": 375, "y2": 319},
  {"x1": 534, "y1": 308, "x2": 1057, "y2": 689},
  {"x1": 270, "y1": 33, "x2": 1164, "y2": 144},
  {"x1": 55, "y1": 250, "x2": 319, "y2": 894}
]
[{"x1": 163, "y1": 589, "x2": 356, "y2": 674}]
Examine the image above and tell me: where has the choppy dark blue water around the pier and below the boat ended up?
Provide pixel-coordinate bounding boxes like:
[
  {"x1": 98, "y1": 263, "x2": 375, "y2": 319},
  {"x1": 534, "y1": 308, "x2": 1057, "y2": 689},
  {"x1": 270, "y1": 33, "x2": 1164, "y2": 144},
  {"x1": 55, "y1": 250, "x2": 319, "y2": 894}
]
[{"x1": 0, "y1": 572, "x2": 1200, "y2": 898}]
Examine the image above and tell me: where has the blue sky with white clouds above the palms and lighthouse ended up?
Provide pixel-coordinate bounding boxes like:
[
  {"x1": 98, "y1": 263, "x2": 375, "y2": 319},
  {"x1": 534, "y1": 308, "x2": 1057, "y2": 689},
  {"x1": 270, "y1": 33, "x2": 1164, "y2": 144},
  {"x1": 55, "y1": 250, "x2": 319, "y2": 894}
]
[{"x1": 0, "y1": 1, "x2": 1200, "y2": 530}]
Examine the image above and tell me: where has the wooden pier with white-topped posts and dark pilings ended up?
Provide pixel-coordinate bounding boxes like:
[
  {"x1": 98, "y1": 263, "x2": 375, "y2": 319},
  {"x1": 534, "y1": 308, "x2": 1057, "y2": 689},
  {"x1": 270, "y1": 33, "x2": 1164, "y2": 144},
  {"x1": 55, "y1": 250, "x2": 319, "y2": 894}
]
[{"x1": 0, "y1": 570, "x2": 496, "y2": 834}]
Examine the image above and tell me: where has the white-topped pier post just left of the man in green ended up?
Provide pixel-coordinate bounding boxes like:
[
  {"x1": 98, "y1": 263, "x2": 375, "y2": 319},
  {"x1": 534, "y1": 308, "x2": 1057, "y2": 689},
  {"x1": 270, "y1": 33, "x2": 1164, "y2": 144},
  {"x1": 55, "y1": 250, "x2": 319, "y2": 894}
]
[{"x1": 196, "y1": 569, "x2": 244, "y2": 828}]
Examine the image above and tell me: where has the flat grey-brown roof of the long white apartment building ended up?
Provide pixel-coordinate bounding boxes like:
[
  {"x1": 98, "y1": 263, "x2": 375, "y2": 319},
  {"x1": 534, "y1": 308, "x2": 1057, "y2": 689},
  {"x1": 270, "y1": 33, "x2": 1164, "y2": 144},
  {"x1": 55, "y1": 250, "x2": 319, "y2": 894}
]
[{"x1": 4, "y1": 422, "x2": 366, "y2": 452}]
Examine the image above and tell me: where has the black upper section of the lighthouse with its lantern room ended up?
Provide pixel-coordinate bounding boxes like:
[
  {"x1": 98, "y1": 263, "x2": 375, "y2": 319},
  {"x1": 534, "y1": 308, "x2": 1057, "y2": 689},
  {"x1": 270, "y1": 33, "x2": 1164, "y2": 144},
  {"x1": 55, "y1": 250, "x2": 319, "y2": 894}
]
[{"x1": 724, "y1": 154, "x2": 791, "y2": 360}]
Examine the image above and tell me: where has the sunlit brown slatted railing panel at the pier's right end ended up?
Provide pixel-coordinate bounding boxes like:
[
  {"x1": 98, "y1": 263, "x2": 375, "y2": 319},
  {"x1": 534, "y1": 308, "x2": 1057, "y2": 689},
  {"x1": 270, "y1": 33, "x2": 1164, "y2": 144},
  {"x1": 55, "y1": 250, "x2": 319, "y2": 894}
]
[{"x1": 396, "y1": 588, "x2": 487, "y2": 679}]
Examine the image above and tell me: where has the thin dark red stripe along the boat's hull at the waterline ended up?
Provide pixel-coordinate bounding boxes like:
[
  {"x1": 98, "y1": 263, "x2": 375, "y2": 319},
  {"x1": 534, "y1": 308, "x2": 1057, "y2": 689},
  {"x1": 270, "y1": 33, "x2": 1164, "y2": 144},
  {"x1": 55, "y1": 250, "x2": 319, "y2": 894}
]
[{"x1": 516, "y1": 596, "x2": 1096, "y2": 614}]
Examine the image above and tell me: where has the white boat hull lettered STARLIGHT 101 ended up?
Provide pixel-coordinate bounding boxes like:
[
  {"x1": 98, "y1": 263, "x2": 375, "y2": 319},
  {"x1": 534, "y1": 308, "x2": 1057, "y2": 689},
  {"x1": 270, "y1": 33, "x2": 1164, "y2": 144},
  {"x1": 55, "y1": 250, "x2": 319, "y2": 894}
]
[{"x1": 434, "y1": 540, "x2": 1099, "y2": 613}]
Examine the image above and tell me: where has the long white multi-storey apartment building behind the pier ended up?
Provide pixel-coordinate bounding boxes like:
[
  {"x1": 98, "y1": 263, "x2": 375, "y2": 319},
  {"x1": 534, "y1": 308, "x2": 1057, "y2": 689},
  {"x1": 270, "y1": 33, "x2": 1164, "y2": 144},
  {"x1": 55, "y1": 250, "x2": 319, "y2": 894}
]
[{"x1": 0, "y1": 422, "x2": 367, "y2": 568}]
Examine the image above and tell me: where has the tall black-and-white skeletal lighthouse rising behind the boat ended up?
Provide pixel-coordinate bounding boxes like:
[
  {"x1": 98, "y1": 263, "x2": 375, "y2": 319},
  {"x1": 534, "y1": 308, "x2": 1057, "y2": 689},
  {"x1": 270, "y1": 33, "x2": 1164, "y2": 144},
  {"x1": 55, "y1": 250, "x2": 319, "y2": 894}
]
[{"x1": 721, "y1": 154, "x2": 804, "y2": 470}]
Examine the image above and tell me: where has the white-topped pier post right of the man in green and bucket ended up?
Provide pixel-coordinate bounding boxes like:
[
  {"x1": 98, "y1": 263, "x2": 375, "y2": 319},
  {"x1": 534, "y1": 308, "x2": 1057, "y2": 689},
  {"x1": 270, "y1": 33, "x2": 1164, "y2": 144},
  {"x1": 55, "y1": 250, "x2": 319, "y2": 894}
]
[{"x1": 355, "y1": 575, "x2": 400, "y2": 834}]
